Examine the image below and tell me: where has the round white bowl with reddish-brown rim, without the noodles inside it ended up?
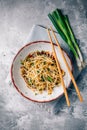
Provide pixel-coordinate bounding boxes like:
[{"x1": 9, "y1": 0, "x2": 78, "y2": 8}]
[{"x1": 11, "y1": 41, "x2": 73, "y2": 102}]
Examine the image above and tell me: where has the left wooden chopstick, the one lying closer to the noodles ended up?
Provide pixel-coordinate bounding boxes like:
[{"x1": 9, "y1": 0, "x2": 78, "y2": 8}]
[{"x1": 47, "y1": 29, "x2": 70, "y2": 106}]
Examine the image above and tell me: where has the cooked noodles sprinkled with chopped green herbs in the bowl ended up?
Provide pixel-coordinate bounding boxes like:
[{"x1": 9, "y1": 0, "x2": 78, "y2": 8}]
[{"x1": 20, "y1": 51, "x2": 65, "y2": 94}]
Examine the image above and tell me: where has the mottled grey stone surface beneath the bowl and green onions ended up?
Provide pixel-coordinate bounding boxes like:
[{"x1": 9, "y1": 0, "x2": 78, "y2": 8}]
[{"x1": 0, "y1": 0, "x2": 87, "y2": 130}]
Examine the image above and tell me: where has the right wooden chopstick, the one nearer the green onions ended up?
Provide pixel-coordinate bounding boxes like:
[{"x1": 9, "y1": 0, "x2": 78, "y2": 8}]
[{"x1": 51, "y1": 27, "x2": 83, "y2": 102}]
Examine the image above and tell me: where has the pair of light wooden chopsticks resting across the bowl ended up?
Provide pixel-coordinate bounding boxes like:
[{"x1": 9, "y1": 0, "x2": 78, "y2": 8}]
[{"x1": 47, "y1": 27, "x2": 83, "y2": 106}]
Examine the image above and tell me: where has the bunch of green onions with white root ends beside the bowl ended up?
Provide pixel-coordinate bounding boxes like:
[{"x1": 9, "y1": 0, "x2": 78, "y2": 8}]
[{"x1": 48, "y1": 9, "x2": 84, "y2": 68}]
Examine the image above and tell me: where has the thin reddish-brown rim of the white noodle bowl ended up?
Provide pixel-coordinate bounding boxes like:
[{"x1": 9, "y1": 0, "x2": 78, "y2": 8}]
[{"x1": 10, "y1": 40, "x2": 73, "y2": 103}]
